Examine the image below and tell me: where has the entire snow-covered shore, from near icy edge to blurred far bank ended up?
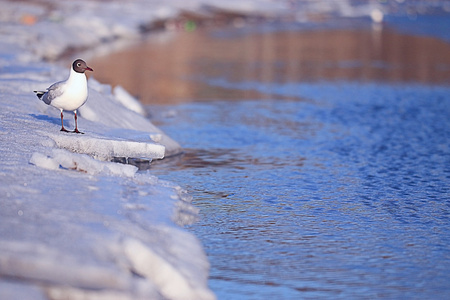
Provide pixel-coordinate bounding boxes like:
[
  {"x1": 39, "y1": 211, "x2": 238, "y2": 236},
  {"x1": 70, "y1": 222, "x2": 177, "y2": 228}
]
[{"x1": 0, "y1": 0, "x2": 448, "y2": 299}]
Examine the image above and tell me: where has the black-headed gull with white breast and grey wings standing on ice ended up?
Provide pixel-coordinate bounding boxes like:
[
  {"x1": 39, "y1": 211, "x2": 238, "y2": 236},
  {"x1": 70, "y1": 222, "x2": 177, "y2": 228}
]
[{"x1": 34, "y1": 59, "x2": 94, "y2": 133}]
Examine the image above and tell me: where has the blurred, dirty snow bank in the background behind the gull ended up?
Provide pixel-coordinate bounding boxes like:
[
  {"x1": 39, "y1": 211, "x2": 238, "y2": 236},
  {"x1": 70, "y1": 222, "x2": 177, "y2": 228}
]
[{"x1": 0, "y1": 0, "x2": 288, "y2": 61}]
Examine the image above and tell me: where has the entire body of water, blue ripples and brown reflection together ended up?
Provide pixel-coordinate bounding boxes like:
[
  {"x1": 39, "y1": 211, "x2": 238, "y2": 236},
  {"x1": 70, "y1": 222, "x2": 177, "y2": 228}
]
[{"x1": 94, "y1": 19, "x2": 450, "y2": 299}]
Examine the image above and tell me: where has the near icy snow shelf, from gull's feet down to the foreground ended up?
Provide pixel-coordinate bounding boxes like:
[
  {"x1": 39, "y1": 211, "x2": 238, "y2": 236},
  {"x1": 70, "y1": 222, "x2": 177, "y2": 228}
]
[{"x1": 0, "y1": 61, "x2": 215, "y2": 299}]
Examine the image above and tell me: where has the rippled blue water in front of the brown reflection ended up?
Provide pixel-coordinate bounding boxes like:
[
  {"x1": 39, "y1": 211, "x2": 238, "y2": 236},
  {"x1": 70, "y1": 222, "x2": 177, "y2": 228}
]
[{"x1": 149, "y1": 80, "x2": 450, "y2": 299}]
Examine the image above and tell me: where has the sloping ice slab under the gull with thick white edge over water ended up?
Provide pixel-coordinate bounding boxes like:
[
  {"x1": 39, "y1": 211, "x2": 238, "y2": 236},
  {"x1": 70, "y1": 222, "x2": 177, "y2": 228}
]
[{"x1": 29, "y1": 74, "x2": 181, "y2": 160}]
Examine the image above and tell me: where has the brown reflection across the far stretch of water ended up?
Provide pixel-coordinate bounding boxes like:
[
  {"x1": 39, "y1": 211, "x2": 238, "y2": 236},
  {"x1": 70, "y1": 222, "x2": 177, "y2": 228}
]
[{"x1": 92, "y1": 21, "x2": 450, "y2": 103}]
